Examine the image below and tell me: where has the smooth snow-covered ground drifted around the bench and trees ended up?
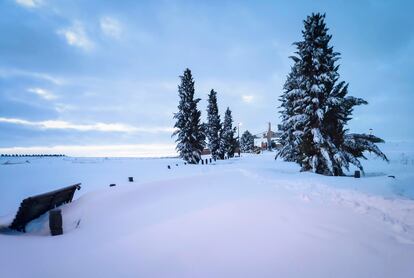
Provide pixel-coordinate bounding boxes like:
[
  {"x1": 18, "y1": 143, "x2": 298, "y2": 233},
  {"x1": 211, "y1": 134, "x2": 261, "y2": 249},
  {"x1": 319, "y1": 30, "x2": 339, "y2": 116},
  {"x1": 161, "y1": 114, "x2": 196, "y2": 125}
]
[{"x1": 0, "y1": 143, "x2": 414, "y2": 277}]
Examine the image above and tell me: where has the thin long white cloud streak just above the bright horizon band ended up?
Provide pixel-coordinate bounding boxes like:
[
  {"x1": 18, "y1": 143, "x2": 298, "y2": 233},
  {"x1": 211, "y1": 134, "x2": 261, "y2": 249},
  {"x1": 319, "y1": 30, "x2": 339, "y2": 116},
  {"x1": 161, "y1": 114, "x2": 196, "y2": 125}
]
[{"x1": 0, "y1": 117, "x2": 174, "y2": 133}]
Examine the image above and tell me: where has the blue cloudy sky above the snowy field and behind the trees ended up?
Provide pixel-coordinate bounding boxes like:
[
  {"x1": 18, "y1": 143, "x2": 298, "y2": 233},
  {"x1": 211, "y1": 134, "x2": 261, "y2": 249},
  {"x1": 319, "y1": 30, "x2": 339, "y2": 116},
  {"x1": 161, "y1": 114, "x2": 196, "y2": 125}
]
[{"x1": 0, "y1": 0, "x2": 414, "y2": 156}]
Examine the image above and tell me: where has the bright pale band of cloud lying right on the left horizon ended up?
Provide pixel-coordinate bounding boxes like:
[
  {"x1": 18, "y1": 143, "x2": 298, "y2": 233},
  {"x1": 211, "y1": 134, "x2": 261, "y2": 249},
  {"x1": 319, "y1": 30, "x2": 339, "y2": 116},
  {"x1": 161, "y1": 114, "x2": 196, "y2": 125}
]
[{"x1": 0, "y1": 144, "x2": 177, "y2": 157}]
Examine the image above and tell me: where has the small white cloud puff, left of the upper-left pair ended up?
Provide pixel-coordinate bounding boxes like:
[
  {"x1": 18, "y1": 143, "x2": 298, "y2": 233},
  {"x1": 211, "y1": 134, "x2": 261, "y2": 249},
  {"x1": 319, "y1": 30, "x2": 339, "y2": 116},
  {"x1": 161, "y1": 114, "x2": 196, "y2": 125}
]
[{"x1": 57, "y1": 21, "x2": 93, "y2": 50}]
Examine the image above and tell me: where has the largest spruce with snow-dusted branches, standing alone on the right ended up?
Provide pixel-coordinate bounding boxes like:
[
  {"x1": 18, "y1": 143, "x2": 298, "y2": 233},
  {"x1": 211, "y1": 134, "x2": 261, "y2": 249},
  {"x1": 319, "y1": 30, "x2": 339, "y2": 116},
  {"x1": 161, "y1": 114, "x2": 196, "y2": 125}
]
[{"x1": 278, "y1": 13, "x2": 387, "y2": 175}]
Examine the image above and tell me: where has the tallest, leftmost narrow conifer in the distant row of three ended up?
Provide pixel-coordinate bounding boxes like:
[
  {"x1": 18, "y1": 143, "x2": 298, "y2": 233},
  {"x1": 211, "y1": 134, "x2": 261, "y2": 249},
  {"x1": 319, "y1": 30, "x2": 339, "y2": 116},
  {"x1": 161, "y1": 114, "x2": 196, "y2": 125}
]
[{"x1": 173, "y1": 68, "x2": 205, "y2": 164}]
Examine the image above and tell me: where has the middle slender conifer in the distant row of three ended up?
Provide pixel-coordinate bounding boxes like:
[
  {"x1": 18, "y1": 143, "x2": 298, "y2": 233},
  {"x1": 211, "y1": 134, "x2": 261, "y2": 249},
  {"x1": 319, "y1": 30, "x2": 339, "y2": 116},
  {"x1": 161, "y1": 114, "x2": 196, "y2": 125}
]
[{"x1": 206, "y1": 89, "x2": 221, "y2": 159}]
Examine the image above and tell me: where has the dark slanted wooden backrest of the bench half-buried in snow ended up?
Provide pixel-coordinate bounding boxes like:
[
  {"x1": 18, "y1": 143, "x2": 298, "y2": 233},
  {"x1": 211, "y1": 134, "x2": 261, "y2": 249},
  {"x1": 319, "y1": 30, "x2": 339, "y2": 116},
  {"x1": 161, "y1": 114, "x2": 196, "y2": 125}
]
[{"x1": 9, "y1": 183, "x2": 81, "y2": 232}]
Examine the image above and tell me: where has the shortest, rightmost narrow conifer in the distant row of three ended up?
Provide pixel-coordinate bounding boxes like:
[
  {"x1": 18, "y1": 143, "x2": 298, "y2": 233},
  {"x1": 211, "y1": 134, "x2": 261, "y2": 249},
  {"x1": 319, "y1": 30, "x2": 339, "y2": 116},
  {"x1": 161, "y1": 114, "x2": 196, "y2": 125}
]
[{"x1": 220, "y1": 107, "x2": 237, "y2": 158}]
